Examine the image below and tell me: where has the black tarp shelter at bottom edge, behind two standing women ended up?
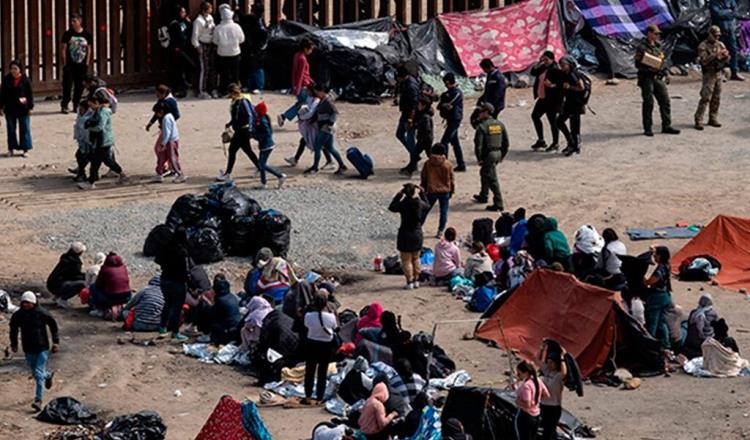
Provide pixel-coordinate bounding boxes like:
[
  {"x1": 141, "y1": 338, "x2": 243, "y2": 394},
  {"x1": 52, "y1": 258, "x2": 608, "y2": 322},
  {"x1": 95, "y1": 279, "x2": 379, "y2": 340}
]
[{"x1": 441, "y1": 387, "x2": 591, "y2": 440}]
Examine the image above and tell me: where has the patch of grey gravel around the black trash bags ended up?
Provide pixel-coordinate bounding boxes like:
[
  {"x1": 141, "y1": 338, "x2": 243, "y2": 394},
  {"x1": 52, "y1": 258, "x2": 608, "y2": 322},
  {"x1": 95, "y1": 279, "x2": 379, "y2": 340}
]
[{"x1": 31, "y1": 187, "x2": 398, "y2": 275}]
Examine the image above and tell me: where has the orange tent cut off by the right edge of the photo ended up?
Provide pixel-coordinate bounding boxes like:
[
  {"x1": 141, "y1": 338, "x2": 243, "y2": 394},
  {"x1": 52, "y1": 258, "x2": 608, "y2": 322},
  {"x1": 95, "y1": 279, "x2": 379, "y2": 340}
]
[{"x1": 672, "y1": 215, "x2": 750, "y2": 289}]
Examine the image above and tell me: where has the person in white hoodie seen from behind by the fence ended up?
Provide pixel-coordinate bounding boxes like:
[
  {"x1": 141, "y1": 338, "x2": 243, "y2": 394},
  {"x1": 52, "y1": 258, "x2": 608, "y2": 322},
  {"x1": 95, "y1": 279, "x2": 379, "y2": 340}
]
[{"x1": 213, "y1": 4, "x2": 245, "y2": 94}]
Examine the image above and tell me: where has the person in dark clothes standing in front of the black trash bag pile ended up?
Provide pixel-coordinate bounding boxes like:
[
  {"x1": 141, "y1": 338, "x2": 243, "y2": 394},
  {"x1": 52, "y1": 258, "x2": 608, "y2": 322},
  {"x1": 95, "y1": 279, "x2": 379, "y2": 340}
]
[{"x1": 155, "y1": 228, "x2": 190, "y2": 342}]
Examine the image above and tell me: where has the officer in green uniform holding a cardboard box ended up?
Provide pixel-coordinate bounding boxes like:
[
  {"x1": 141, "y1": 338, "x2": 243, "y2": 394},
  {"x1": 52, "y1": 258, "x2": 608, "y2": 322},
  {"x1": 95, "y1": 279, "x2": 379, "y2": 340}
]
[{"x1": 635, "y1": 24, "x2": 680, "y2": 136}]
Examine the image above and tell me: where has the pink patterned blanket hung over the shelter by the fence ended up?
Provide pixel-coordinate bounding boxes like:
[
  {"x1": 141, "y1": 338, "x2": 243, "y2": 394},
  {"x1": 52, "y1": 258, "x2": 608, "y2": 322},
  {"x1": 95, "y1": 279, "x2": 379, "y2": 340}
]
[{"x1": 439, "y1": 0, "x2": 565, "y2": 77}]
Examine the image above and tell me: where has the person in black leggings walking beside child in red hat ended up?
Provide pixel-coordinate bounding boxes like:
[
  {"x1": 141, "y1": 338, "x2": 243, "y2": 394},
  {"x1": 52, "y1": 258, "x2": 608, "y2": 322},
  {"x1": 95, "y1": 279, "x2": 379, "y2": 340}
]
[{"x1": 216, "y1": 83, "x2": 260, "y2": 182}]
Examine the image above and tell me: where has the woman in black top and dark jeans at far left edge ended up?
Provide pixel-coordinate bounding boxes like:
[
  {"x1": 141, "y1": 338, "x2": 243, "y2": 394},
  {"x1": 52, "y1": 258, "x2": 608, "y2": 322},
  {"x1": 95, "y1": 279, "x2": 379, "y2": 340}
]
[{"x1": 0, "y1": 60, "x2": 34, "y2": 157}]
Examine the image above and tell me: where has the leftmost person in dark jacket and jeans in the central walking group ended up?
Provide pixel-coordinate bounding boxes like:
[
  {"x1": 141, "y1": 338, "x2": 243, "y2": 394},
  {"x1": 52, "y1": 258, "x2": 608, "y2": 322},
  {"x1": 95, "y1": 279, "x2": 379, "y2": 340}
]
[{"x1": 396, "y1": 66, "x2": 419, "y2": 176}]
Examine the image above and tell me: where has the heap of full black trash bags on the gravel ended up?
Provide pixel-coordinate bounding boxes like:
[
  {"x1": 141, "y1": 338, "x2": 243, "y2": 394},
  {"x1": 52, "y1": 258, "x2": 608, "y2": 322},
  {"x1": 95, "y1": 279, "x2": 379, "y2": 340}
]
[{"x1": 143, "y1": 181, "x2": 292, "y2": 264}]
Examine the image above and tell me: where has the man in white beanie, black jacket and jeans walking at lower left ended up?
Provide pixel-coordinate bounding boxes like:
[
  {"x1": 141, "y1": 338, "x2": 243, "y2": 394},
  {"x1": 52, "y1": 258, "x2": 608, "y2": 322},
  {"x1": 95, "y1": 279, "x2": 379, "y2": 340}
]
[{"x1": 10, "y1": 292, "x2": 60, "y2": 411}]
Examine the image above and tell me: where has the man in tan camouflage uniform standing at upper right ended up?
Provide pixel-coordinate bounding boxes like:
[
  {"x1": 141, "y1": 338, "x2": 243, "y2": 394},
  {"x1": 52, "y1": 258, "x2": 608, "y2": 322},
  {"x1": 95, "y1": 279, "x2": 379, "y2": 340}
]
[{"x1": 695, "y1": 26, "x2": 729, "y2": 130}]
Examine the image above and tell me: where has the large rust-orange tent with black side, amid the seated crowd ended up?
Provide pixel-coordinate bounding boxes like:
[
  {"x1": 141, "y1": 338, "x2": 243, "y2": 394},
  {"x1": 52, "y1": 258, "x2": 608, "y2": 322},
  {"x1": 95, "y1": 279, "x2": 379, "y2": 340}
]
[{"x1": 476, "y1": 269, "x2": 663, "y2": 377}]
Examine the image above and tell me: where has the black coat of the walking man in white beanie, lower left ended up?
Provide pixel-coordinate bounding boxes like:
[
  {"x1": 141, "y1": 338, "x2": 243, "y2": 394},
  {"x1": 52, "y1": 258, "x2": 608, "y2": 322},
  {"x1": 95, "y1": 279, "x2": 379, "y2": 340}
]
[{"x1": 10, "y1": 305, "x2": 60, "y2": 354}]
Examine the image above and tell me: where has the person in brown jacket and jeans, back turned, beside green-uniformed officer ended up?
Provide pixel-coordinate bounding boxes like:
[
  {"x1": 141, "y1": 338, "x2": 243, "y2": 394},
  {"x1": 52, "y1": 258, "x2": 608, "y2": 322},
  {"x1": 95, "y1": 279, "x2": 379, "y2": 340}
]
[{"x1": 421, "y1": 144, "x2": 456, "y2": 238}]
